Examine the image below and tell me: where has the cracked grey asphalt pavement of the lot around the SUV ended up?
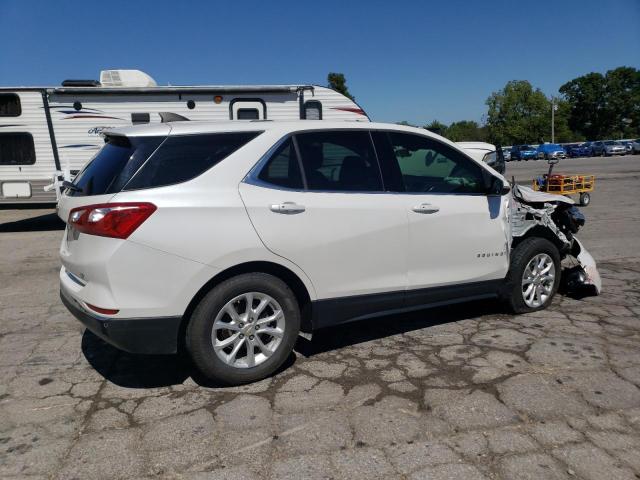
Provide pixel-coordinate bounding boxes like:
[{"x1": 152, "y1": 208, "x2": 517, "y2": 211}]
[{"x1": 0, "y1": 157, "x2": 640, "y2": 480}]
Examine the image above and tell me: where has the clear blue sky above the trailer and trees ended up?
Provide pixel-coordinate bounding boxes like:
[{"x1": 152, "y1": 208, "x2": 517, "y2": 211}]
[{"x1": 0, "y1": 0, "x2": 640, "y2": 125}]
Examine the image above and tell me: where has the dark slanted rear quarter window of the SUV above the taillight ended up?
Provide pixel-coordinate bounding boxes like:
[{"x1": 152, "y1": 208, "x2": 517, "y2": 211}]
[{"x1": 125, "y1": 132, "x2": 262, "y2": 190}]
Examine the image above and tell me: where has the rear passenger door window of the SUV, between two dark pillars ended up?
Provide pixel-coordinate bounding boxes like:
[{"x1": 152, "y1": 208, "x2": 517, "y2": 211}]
[{"x1": 296, "y1": 130, "x2": 382, "y2": 192}]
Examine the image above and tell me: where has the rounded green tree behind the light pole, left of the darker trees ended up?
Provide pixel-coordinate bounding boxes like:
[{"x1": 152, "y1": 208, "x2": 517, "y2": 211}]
[{"x1": 486, "y1": 80, "x2": 551, "y2": 145}]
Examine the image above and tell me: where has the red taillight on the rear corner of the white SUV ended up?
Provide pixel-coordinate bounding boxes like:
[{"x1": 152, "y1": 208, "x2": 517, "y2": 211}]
[{"x1": 68, "y1": 202, "x2": 157, "y2": 239}]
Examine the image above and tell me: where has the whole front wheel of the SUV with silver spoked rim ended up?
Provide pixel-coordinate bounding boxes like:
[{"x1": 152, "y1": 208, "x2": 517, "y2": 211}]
[{"x1": 504, "y1": 237, "x2": 560, "y2": 313}]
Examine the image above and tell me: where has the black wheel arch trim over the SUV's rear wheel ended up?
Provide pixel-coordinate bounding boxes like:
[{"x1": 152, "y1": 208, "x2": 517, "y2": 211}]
[{"x1": 178, "y1": 261, "x2": 313, "y2": 345}]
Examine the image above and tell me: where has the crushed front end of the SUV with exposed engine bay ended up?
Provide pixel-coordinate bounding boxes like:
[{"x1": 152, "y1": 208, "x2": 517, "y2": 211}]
[{"x1": 509, "y1": 181, "x2": 602, "y2": 297}]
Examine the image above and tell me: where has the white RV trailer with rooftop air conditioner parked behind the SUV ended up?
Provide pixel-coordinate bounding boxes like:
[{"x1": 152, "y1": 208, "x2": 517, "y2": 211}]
[{"x1": 0, "y1": 70, "x2": 369, "y2": 204}]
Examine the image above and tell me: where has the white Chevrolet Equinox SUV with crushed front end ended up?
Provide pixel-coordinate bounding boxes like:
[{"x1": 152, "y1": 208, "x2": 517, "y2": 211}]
[{"x1": 59, "y1": 121, "x2": 600, "y2": 384}]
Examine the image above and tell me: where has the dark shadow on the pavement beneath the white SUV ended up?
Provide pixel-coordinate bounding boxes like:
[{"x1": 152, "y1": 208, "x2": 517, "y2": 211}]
[{"x1": 82, "y1": 301, "x2": 500, "y2": 388}]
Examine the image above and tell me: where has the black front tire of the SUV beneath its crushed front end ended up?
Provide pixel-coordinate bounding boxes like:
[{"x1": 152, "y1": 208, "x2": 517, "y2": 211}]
[{"x1": 504, "y1": 237, "x2": 560, "y2": 313}]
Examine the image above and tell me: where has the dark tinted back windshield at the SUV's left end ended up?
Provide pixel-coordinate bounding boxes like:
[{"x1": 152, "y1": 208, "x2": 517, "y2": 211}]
[{"x1": 67, "y1": 136, "x2": 166, "y2": 196}]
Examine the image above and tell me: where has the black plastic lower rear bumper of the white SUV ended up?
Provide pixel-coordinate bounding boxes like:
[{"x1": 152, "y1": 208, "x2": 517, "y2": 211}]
[{"x1": 60, "y1": 289, "x2": 182, "y2": 354}]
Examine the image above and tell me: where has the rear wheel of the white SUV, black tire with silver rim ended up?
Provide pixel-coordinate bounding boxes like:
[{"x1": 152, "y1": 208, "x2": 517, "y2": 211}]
[{"x1": 186, "y1": 273, "x2": 300, "y2": 385}]
